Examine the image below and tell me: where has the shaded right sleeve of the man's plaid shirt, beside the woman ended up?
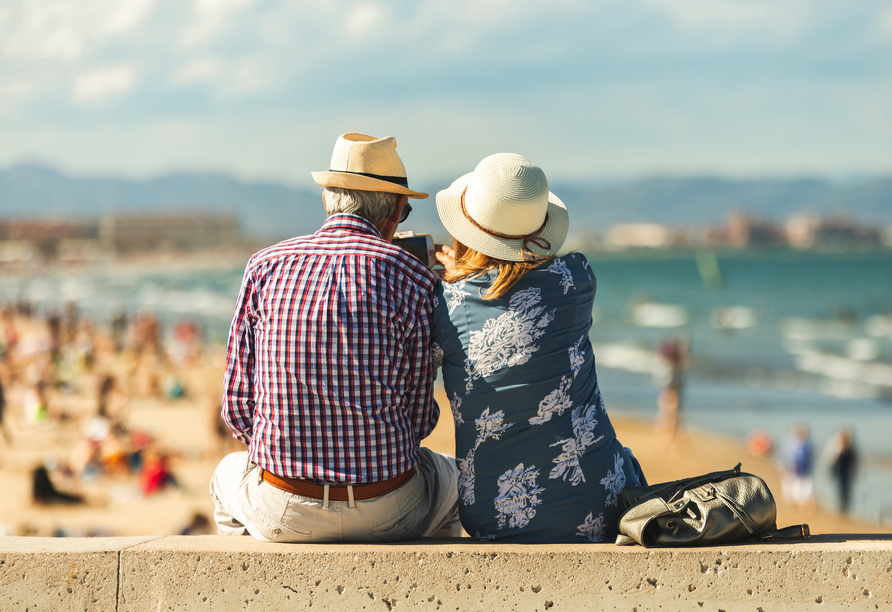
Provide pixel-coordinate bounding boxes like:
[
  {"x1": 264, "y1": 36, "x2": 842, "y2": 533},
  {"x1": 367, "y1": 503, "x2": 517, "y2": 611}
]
[{"x1": 407, "y1": 295, "x2": 440, "y2": 442}]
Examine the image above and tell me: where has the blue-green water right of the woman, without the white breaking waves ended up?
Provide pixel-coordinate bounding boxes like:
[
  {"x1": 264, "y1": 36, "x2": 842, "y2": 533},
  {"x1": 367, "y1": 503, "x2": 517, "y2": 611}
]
[{"x1": 589, "y1": 252, "x2": 892, "y2": 522}]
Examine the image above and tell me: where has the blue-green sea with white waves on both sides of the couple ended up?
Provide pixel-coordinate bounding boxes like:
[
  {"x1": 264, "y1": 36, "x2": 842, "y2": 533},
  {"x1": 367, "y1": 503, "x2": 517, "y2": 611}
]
[{"x1": 0, "y1": 250, "x2": 892, "y2": 524}]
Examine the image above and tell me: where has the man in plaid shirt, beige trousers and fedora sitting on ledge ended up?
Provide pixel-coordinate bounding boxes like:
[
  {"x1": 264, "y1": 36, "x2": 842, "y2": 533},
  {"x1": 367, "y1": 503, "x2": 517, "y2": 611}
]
[{"x1": 211, "y1": 134, "x2": 461, "y2": 542}]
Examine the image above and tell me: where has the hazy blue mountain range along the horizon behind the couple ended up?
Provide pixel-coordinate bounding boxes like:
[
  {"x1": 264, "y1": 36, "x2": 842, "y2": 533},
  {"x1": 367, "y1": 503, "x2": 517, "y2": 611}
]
[{"x1": 0, "y1": 165, "x2": 892, "y2": 240}]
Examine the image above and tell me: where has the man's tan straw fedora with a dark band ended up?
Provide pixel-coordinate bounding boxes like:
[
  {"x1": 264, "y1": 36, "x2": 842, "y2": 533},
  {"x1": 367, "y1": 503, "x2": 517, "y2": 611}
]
[{"x1": 312, "y1": 132, "x2": 428, "y2": 199}]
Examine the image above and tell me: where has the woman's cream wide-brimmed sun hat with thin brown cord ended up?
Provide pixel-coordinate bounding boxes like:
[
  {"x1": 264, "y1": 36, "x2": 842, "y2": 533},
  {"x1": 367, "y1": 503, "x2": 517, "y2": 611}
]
[{"x1": 437, "y1": 153, "x2": 570, "y2": 261}]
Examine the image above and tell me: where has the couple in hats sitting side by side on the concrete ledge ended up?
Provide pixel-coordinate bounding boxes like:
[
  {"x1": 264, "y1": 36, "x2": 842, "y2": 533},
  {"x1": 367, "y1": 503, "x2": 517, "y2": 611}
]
[{"x1": 211, "y1": 133, "x2": 644, "y2": 542}]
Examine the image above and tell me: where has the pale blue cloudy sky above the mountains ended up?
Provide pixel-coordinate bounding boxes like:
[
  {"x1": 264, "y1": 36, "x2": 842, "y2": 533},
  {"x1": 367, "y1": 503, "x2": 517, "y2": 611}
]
[{"x1": 0, "y1": 0, "x2": 892, "y2": 186}]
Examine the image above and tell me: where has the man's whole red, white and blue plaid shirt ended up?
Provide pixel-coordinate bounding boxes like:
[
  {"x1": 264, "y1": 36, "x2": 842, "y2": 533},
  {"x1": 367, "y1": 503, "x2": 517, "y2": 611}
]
[{"x1": 223, "y1": 214, "x2": 440, "y2": 483}]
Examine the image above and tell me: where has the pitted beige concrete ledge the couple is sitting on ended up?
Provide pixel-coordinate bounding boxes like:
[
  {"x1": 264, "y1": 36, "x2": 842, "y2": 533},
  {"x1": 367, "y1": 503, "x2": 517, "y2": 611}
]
[{"x1": 0, "y1": 534, "x2": 892, "y2": 612}]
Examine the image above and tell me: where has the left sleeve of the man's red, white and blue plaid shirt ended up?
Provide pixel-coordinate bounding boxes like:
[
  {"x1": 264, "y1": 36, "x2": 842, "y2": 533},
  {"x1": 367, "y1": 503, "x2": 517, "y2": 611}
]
[{"x1": 222, "y1": 262, "x2": 257, "y2": 444}]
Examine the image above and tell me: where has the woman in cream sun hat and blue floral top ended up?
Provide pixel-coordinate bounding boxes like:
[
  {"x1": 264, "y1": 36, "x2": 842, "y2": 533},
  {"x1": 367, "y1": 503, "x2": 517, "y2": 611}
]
[{"x1": 433, "y1": 153, "x2": 644, "y2": 542}]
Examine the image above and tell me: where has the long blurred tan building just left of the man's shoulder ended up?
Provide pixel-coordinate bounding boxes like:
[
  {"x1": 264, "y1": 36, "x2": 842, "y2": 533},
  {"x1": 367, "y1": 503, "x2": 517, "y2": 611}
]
[{"x1": 99, "y1": 215, "x2": 238, "y2": 254}]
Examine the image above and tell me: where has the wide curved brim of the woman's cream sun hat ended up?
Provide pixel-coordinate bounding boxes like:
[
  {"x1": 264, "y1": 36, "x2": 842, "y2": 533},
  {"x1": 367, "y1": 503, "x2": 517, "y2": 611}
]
[{"x1": 437, "y1": 172, "x2": 570, "y2": 261}]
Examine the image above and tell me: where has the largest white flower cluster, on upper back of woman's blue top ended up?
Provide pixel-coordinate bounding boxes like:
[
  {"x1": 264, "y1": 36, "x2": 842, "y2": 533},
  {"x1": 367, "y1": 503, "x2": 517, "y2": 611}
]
[{"x1": 465, "y1": 287, "x2": 554, "y2": 394}]
